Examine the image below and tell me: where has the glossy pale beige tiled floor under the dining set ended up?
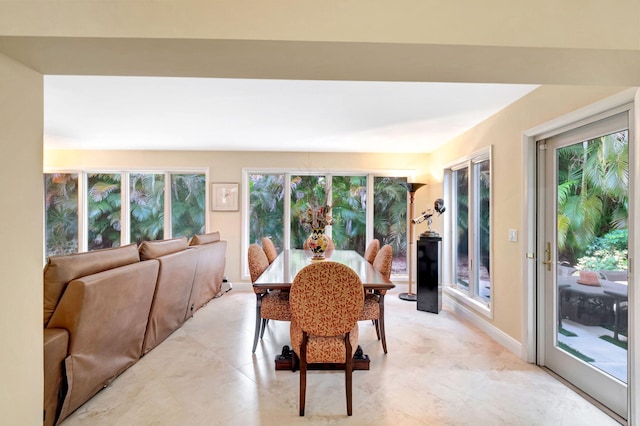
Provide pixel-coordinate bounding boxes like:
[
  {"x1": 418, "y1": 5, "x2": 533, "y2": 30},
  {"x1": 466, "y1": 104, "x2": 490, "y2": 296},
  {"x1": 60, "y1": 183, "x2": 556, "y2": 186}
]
[{"x1": 63, "y1": 284, "x2": 618, "y2": 426}]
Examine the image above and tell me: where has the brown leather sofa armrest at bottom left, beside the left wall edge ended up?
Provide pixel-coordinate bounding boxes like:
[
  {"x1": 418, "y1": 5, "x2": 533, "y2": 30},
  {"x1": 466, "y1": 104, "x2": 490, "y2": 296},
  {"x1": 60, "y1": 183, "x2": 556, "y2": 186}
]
[{"x1": 43, "y1": 328, "x2": 69, "y2": 426}]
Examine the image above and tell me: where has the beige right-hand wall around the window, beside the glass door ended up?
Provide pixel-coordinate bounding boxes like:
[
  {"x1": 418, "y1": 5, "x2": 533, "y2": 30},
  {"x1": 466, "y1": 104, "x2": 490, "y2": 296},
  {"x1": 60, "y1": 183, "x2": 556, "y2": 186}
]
[{"x1": 429, "y1": 86, "x2": 623, "y2": 342}]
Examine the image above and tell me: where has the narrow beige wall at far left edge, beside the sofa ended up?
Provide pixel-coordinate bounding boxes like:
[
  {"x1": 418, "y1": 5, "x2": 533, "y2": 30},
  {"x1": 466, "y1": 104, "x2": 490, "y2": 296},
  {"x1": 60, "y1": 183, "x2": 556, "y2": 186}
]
[{"x1": 0, "y1": 55, "x2": 43, "y2": 425}]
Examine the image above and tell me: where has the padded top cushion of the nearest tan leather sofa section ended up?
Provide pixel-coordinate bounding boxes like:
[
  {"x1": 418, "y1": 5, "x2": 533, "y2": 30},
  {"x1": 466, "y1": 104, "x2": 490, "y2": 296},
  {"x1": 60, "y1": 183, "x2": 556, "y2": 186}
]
[{"x1": 44, "y1": 244, "x2": 140, "y2": 327}]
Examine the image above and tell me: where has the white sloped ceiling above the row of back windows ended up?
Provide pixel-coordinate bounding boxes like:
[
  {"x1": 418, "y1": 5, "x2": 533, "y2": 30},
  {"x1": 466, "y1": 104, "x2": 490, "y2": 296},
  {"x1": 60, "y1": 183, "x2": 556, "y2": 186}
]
[{"x1": 44, "y1": 76, "x2": 538, "y2": 153}]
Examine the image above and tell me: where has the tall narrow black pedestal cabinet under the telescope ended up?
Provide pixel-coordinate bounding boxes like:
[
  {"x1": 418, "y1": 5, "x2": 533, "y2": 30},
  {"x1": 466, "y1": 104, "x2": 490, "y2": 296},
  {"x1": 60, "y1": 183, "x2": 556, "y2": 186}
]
[{"x1": 416, "y1": 237, "x2": 442, "y2": 314}]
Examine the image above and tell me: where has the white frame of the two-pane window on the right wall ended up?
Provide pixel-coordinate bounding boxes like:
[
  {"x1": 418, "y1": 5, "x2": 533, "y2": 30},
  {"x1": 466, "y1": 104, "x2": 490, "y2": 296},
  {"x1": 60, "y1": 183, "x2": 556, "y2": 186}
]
[{"x1": 442, "y1": 146, "x2": 494, "y2": 318}]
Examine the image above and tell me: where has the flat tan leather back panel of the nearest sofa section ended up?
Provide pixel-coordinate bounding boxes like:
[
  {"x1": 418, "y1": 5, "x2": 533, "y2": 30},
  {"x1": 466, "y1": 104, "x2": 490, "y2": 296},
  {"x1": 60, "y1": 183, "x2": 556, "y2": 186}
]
[{"x1": 49, "y1": 260, "x2": 158, "y2": 420}]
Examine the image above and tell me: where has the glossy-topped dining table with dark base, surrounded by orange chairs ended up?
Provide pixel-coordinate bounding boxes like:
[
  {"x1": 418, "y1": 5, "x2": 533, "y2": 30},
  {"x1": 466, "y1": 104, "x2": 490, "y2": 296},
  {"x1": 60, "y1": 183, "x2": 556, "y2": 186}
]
[{"x1": 253, "y1": 249, "x2": 395, "y2": 370}]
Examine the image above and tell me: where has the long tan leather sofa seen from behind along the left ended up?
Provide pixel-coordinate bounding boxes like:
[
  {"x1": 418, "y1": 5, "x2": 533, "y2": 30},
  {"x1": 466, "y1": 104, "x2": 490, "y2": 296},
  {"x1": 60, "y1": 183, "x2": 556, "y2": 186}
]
[{"x1": 44, "y1": 233, "x2": 226, "y2": 425}]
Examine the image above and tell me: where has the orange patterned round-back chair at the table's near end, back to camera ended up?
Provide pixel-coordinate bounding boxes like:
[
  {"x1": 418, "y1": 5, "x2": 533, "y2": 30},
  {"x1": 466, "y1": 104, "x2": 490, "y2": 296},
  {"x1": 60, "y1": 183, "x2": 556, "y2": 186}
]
[{"x1": 289, "y1": 261, "x2": 364, "y2": 416}]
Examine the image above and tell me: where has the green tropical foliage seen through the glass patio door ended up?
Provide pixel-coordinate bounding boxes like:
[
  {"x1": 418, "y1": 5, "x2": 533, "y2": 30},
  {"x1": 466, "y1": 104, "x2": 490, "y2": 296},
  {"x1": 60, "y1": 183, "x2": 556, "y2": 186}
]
[{"x1": 558, "y1": 130, "x2": 629, "y2": 271}]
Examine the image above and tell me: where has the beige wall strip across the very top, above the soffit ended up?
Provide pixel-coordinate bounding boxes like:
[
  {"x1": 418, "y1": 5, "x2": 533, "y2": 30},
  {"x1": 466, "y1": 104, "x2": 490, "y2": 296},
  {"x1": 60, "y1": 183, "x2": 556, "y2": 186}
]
[{"x1": 0, "y1": 0, "x2": 640, "y2": 49}]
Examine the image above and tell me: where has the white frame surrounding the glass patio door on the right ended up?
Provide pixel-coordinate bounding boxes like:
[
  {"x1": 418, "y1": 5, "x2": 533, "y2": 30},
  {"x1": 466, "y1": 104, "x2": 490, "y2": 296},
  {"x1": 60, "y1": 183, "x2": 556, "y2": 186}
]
[{"x1": 521, "y1": 88, "x2": 640, "y2": 425}]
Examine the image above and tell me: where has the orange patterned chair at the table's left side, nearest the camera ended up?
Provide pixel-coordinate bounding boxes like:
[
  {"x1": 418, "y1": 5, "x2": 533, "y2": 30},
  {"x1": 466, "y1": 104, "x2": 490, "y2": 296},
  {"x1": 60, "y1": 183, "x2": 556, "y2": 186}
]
[{"x1": 248, "y1": 244, "x2": 291, "y2": 353}]
